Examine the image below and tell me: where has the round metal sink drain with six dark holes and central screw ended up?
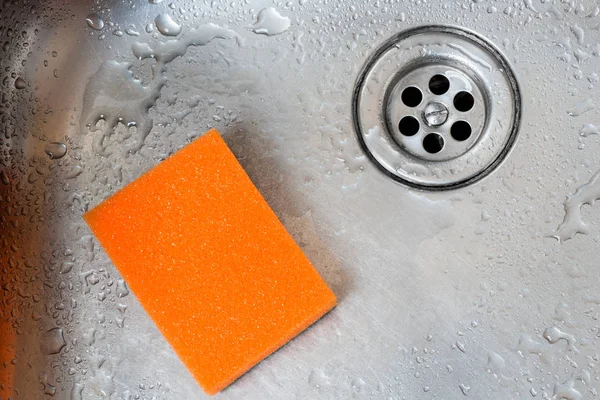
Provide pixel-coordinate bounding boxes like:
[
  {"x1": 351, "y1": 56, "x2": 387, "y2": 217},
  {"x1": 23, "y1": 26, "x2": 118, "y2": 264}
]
[{"x1": 353, "y1": 26, "x2": 521, "y2": 190}]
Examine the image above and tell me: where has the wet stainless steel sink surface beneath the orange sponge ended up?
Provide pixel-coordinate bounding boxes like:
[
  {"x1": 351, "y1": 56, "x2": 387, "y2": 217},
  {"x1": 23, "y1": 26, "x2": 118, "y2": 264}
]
[{"x1": 0, "y1": 0, "x2": 600, "y2": 400}]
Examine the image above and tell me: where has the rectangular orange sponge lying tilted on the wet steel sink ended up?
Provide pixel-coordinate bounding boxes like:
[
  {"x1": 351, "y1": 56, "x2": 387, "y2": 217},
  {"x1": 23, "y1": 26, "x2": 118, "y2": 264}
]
[{"x1": 84, "y1": 129, "x2": 336, "y2": 395}]
